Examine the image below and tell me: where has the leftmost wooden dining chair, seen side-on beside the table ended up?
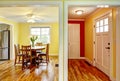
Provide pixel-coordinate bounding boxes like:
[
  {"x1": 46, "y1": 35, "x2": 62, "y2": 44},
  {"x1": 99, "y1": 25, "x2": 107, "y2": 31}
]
[{"x1": 14, "y1": 44, "x2": 22, "y2": 65}]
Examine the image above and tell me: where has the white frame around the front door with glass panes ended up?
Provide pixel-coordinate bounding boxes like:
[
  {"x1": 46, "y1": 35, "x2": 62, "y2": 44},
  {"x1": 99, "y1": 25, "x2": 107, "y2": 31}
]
[{"x1": 93, "y1": 10, "x2": 113, "y2": 77}]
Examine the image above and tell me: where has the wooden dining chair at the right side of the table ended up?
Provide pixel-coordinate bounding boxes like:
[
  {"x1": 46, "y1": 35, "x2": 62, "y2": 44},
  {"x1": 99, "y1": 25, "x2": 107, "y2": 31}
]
[{"x1": 38, "y1": 44, "x2": 49, "y2": 64}]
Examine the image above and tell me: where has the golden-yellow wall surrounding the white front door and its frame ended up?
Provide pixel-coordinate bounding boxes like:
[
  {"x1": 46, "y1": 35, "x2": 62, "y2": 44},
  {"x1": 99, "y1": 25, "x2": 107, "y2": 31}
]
[{"x1": 85, "y1": 8, "x2": 116, "y2": 78}]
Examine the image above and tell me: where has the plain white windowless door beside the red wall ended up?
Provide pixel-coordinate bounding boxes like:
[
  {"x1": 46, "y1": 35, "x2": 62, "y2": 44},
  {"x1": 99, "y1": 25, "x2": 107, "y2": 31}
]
[{"x1": 68, "y1": 24, "x2": 80, "y2": 59}]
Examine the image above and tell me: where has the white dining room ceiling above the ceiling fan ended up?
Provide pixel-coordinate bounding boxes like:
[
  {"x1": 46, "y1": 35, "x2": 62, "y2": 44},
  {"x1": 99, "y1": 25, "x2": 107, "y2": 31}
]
[{"x1": 0, "y1": 6, "x2": 59, "y2": 23}]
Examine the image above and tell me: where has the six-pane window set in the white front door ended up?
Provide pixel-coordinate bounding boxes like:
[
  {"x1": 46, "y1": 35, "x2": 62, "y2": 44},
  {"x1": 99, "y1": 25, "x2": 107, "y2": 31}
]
[{"x1": 95, "y1": 17, "x2": 109, "y2": 33}]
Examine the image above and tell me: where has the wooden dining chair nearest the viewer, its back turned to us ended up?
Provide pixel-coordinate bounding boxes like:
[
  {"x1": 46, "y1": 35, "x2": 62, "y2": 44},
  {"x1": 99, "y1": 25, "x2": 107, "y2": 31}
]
[{"x1": 21, "y1": 45, "x2": 32, "y2": 70}]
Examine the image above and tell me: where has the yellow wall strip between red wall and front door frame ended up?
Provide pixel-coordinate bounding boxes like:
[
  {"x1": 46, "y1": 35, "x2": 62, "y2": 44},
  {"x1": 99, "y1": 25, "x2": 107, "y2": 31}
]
[{"x1": 85, "y1": 18, "x2": 93, "y2": 61}]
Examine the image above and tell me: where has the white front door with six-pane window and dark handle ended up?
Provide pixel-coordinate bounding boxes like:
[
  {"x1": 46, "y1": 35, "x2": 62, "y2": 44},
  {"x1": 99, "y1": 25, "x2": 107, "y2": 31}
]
[{"x1": 95, "y1": 15, "x2": 111, "y2": 75}]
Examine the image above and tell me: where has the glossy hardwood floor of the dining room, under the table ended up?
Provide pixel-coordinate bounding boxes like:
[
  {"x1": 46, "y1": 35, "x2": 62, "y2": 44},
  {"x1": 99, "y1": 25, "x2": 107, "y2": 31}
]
[{"x1": 0, "y1": 57, "x2": 58, "y2": 81}]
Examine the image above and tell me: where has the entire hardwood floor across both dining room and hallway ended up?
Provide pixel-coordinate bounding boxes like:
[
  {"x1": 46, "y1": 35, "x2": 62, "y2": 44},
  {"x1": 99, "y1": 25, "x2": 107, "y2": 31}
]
[{"x1": 0, "y1": 57, "x2": 110, "y2": 81}]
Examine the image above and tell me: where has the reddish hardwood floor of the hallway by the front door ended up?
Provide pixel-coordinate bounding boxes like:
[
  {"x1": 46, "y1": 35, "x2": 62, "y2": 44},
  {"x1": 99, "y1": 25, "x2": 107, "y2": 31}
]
[{"x1": 68, "y1": 59, "x2": 110, "y2": 81}]
